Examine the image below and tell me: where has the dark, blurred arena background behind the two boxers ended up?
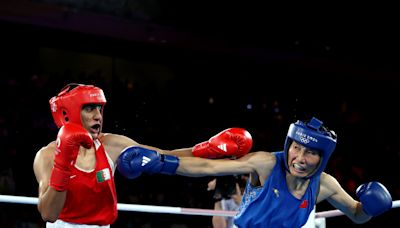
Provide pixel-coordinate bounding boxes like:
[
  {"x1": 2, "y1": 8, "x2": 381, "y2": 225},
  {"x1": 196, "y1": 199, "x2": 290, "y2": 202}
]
[{"x1": 0, "y1": 0, "x2": 400, "y2": 228}]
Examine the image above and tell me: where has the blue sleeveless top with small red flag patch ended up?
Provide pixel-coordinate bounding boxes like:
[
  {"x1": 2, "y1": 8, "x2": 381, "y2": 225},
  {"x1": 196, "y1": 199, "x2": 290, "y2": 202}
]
[{"x1": 235, "y1": 151, "x2": 320, "y2": 228}]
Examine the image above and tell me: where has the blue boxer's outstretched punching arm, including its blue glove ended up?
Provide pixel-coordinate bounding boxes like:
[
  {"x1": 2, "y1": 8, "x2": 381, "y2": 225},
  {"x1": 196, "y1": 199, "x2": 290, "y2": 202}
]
[{"x1": 117, "y1": 146, "x2": 270, "y2": 179}]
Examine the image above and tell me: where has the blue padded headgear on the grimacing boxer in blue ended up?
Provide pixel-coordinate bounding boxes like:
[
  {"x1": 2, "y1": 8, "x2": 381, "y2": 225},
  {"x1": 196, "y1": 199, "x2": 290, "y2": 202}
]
[{"x1": 284, "y1": 117, "x2": 336, "y2": 178}]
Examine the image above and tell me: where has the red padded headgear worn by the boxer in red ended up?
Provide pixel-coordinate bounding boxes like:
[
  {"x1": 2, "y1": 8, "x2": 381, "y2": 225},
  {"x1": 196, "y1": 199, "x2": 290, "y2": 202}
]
[{"x1": 49, "y1": 84, "x2": 107, "y2": 128}]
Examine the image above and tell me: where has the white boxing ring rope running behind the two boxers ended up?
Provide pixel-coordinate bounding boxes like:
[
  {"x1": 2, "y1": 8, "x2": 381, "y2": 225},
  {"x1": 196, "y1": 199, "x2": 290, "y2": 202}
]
[{"x1": 0, "y1": 195, "x2": 400, "y2": 218}]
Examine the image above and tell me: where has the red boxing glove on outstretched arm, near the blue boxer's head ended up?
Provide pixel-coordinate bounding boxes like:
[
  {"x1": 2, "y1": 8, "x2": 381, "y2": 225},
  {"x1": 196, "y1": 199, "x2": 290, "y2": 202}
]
[{"x1": 192, "y1": 128, "x2": 253, "y2": 158}]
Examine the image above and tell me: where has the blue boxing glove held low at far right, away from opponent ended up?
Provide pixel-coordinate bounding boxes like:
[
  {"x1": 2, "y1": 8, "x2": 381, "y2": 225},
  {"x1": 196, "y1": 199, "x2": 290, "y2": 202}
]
[{"x1": 356, "y1": 182, "x2": 392, "y2": 216}]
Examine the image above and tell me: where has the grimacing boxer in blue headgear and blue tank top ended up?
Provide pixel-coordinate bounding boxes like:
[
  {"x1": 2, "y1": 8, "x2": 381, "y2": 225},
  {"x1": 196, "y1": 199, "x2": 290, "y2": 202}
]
[{"x1": 144, "y1": 118, "x2": 392, "y2": 228}]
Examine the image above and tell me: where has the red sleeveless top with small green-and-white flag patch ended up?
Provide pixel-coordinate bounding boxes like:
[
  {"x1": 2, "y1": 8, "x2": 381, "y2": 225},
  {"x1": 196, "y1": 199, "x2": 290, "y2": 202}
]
[{"x1": 59, "y1": 141, "x2": 118, "y2": 225}]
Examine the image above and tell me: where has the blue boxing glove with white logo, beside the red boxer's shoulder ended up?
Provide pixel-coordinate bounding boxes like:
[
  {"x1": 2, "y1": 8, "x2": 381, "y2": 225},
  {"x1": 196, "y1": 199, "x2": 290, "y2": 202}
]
[{"x1": 117, "y1": 146, "x2": 179, "y2": 179}]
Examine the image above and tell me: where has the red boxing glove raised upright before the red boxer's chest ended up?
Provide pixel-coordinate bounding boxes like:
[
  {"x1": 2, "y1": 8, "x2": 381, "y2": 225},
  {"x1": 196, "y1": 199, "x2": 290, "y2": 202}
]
[{"x1": 50, "y1": 123, "x2": 93, "y2": 191}]
